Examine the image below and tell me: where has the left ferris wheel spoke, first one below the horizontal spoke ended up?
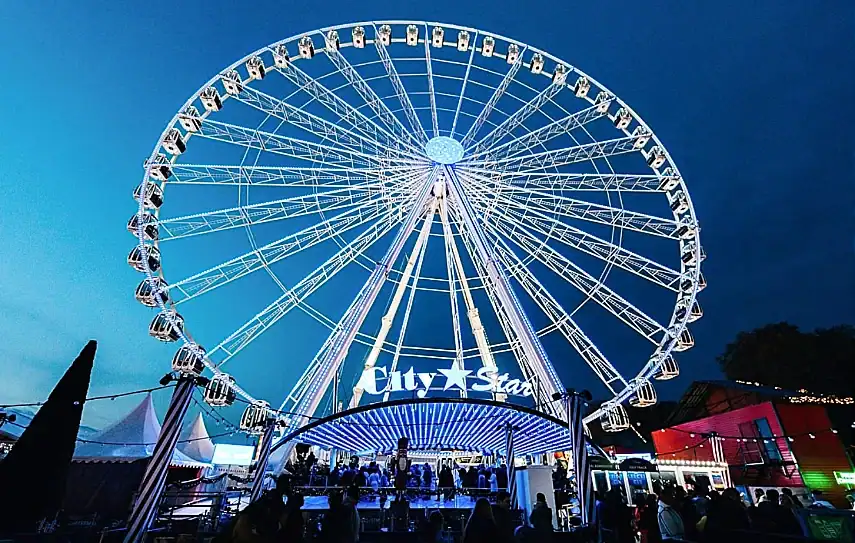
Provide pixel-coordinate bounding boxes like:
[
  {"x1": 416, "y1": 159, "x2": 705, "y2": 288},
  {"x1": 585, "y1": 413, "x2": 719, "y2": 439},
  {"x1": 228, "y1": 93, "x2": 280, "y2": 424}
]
[{"x1": 157, "y1": 180, "x2": 402, "y2": 242}]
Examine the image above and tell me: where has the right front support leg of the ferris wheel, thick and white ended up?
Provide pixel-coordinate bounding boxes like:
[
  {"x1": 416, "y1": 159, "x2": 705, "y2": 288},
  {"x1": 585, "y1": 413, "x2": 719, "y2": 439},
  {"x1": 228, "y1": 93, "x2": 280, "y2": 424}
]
[{"x1": 445, "y1": 166, "x2": 565, "y2": 416}]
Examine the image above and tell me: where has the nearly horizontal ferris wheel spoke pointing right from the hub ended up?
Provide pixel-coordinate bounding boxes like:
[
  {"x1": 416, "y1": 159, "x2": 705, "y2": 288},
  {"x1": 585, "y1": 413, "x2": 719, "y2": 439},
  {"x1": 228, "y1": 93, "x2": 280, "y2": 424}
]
[{"x1": 460, "y1": 171, "x2": 669, "y2": 193}]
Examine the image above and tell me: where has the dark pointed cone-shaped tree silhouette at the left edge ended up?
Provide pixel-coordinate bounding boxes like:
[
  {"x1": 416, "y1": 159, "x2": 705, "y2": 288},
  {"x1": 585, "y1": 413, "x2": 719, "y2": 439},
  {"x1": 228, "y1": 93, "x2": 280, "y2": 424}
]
[{"x1": 0, "y1": 341, "x2": 97, "y2": 534}]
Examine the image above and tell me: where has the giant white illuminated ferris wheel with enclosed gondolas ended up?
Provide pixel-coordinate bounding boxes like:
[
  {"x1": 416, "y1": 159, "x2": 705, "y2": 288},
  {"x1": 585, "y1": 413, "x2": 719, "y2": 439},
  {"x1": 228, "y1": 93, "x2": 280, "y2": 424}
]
[{"x1": 128, "y1": 21, "x2": 706, "y2": 440}]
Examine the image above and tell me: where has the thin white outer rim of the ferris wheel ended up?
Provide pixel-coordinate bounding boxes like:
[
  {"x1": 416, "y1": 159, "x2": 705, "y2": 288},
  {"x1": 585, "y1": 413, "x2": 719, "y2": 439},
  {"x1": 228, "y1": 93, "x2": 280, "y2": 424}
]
[{"x1": 137, "y1": 20, "x2": 700, "y2": 430}]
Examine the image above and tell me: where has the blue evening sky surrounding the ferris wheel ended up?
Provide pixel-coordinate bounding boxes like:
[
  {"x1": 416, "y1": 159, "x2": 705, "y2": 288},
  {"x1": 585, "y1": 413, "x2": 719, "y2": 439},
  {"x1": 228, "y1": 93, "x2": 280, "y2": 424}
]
[{"x1": 0, "y1": 0, "x2": 855, "y2": 433}]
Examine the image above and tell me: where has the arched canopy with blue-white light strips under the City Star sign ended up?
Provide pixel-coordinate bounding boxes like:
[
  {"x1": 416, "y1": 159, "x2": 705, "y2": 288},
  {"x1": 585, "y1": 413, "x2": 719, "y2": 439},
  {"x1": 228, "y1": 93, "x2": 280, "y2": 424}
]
[{"x1": 277, "y1": 398, "x2": 571, "y2": 456}]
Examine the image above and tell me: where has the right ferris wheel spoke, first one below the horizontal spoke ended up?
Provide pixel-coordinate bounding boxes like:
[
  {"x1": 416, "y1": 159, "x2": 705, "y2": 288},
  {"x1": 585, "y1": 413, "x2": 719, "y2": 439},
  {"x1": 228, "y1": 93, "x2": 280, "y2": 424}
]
[{"x1": 468, "y1": 170, "x2": 682, "y2": 239}]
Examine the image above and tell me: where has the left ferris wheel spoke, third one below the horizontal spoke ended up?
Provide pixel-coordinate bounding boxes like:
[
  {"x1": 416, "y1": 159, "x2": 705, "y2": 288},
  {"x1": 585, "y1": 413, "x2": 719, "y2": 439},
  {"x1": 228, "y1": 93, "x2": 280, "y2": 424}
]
[{"x1": 208, "y1": 208, "x2": 406, "y2": 368}]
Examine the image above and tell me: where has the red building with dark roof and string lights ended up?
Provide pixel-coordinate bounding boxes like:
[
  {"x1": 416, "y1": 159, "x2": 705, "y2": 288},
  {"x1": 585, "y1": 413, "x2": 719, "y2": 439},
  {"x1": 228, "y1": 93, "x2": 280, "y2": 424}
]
[{"x1": 652, "y1": 381, "x2": 853, "y2": 507}]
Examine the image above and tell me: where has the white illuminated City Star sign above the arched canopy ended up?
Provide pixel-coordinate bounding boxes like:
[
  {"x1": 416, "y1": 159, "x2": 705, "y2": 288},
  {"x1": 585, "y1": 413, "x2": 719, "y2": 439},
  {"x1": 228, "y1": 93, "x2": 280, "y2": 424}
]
[{"x1": 356, "y1": 366, "x2": 531, "y2": 398}]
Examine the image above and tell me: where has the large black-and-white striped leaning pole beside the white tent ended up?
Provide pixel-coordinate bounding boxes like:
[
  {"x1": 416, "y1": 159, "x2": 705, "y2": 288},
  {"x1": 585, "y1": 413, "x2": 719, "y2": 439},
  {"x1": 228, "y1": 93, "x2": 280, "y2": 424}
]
[{"x1": 124, "y1": 376, "x2": 196, "y2": 543}]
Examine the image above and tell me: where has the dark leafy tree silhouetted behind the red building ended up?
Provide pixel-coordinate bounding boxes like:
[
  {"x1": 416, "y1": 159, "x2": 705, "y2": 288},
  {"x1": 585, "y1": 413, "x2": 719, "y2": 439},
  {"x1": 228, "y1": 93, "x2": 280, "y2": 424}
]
[{"x1": 718, "y1": 322, "x2": 855, "y2": 396}]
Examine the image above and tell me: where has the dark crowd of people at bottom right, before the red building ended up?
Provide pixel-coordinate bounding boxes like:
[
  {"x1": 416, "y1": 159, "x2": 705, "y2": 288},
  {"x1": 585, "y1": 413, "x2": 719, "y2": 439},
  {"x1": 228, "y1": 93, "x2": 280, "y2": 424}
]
[{"x1": 596, "y1": 480, "x2": 830, "y2": 543}]
